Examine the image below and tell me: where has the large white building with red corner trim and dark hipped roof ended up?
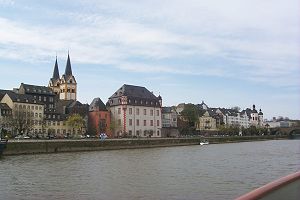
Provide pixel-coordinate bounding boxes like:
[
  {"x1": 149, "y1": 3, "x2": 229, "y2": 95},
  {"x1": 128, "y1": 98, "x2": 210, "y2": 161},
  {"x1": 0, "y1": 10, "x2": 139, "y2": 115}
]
[{"x1": 108, "y1": 84, "x2": 162, "y2": 137}]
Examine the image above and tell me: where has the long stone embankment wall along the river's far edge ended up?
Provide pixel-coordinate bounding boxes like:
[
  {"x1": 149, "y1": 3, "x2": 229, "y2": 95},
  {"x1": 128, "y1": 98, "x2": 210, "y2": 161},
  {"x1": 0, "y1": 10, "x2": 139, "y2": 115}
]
[{"x1": 3, "y1": 136, "x2": 287, "y2": 155}]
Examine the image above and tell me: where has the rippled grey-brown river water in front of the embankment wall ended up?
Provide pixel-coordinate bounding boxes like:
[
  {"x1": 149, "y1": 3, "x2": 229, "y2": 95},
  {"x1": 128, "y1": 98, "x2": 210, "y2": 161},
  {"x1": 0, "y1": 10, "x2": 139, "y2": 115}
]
[{"x1": 0, "y1": 140, "x2": 300, "y2": 200}]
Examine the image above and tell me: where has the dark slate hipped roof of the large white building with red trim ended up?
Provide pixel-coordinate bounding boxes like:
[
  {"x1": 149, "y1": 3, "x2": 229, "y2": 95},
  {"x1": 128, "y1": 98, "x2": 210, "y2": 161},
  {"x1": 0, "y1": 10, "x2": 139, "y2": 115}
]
[{"x1": 108, "y1": 84, "x2": 161, "y2": 107}]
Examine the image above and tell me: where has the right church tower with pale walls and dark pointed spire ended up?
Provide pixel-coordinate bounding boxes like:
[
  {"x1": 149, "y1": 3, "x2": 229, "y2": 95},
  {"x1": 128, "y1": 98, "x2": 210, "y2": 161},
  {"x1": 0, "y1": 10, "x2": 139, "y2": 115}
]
[{"x1": 59, "y1": 53, "x2": 77, "y2": 101}]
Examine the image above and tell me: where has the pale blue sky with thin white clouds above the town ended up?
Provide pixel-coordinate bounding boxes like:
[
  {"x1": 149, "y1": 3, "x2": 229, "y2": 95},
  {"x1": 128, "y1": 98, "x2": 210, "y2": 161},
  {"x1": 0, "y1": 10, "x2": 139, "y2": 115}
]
[{"x1": 0, "y1": 0, "x2": 300, "y2": 119}]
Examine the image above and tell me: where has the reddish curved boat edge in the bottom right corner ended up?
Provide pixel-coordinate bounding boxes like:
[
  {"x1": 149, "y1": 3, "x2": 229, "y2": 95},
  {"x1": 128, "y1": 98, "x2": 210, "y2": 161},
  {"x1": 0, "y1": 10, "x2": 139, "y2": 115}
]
[{"x1": 236, "y1": 171, "x2": 300, "y2": 200}]
